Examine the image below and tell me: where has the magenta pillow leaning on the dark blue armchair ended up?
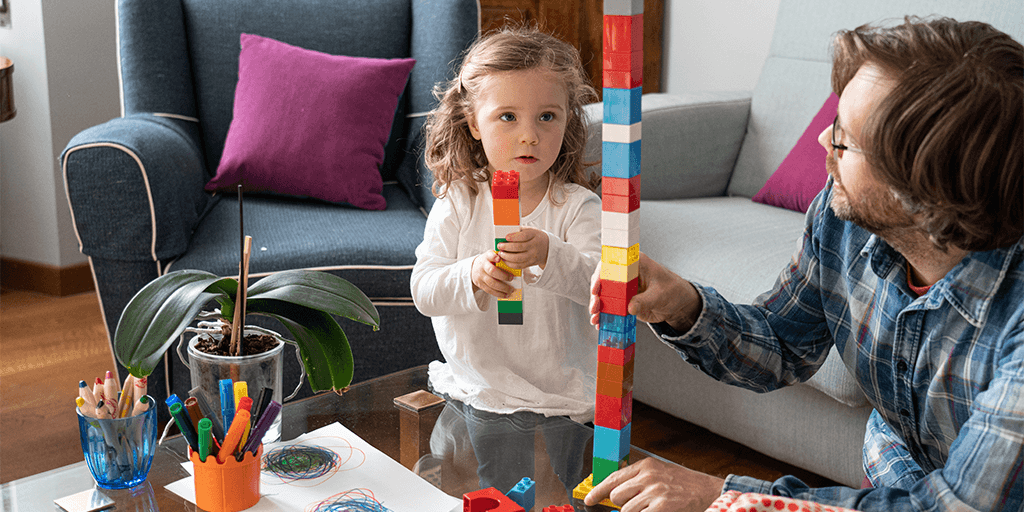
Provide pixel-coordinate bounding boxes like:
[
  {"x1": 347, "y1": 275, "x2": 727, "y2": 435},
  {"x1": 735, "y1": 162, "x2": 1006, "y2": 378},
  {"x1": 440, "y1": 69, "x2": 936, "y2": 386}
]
[{"x1": 206, "y1": 34, "x2": 416, "y2": 210}]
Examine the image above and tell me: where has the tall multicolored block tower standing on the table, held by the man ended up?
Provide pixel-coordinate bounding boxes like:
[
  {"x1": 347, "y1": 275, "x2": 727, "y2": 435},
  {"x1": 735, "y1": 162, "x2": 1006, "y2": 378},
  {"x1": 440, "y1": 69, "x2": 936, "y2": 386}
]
[{"x1": 573, "y1": 0, "x2": 643, "y2": 505}]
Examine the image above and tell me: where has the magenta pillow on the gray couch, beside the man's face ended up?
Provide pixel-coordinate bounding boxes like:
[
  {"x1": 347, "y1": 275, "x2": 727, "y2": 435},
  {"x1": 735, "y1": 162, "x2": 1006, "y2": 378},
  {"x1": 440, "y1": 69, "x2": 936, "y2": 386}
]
[{"x1": 751, "y1": 93, "x2": 839, "y2": 212}]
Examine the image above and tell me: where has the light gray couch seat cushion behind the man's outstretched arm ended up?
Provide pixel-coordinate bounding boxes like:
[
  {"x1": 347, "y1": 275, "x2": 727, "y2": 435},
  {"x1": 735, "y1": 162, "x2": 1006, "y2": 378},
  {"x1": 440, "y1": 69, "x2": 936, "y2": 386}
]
[{"x1": 640, "y1": 198, "x2": 867, "y2": 407}]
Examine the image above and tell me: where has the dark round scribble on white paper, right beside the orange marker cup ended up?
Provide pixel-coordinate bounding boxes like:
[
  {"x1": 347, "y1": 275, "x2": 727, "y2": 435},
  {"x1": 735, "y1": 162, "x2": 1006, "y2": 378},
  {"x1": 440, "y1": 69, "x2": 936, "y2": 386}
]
[{"x1": 262, "y1": 436, "x2": 366, "y2": 487}]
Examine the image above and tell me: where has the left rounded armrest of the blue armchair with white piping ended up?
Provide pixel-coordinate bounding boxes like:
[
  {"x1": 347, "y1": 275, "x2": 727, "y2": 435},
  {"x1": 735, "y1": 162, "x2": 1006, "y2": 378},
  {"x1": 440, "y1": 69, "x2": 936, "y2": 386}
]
[{"x1": 60, "y1": 115, "x2": 211, "y2": 261}]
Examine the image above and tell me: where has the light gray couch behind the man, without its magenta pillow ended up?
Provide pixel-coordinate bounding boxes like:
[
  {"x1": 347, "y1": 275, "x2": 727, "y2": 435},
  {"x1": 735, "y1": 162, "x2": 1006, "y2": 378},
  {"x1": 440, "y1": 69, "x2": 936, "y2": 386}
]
[{"x1": 588, "y1": 0, "x2": 1024, "y2": 486}]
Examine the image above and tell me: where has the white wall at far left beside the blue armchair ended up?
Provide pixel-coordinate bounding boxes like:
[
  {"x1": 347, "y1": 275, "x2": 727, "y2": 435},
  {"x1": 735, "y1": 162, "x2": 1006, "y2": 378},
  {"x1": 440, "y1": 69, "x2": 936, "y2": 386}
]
[{"x1": 0, "y1": 0, "x2": 121, "y2": 267}]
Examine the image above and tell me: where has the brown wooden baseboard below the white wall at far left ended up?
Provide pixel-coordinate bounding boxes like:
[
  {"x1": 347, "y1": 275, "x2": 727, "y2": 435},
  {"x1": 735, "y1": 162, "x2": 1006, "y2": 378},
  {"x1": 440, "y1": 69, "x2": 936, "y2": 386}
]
[{"x1": 0, "y1": 258, "x2": 95, "y2": 297}]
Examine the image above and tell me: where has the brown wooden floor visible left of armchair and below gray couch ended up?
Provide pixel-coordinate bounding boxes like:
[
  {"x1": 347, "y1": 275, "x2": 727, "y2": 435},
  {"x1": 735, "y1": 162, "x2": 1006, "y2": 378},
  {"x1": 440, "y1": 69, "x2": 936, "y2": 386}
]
[{"x1": 0, "y1": 291, "x2": 835, "y2": 486}]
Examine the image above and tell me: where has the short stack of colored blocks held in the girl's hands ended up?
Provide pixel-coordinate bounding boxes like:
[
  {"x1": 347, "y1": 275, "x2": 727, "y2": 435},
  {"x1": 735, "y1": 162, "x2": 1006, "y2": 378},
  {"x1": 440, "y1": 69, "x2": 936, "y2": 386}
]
[{"x1": 490, "y1": 171, "x2": 522, "y2": 326}]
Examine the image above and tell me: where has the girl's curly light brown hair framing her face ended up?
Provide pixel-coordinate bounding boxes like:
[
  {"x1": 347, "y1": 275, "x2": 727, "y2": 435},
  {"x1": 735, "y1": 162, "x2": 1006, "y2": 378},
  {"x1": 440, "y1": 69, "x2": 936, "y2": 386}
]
[{"x1": 424, "y1": 27, "x2": 601, "y2": 198}]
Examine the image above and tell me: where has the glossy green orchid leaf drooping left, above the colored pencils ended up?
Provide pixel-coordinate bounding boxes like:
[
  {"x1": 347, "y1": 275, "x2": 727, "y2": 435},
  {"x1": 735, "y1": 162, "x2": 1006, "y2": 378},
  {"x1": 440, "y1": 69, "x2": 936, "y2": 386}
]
[{"x1": 114, "y1": 270, "x2": 238, "y2": 377}]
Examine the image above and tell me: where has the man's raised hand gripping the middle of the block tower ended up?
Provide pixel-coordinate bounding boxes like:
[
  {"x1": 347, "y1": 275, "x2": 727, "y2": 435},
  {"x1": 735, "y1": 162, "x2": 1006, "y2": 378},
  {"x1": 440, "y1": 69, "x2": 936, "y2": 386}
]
[{"x1": 590, "y1": 253, "x2": 703, "y2": 332}]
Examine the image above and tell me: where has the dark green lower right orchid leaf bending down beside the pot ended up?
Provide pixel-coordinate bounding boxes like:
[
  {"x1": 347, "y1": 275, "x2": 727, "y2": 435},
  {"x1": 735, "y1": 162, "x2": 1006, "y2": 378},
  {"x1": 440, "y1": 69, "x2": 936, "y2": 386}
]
[{"x1": 247, "y1": 299, "x2": 354, "y2": 391}]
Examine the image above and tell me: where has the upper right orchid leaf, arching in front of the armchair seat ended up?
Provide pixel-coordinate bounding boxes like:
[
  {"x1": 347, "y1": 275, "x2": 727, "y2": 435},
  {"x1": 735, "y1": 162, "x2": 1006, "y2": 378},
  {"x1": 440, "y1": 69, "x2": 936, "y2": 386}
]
[{"x1": 247, "y1": 270, "x2": 380, "y2": 331}]
